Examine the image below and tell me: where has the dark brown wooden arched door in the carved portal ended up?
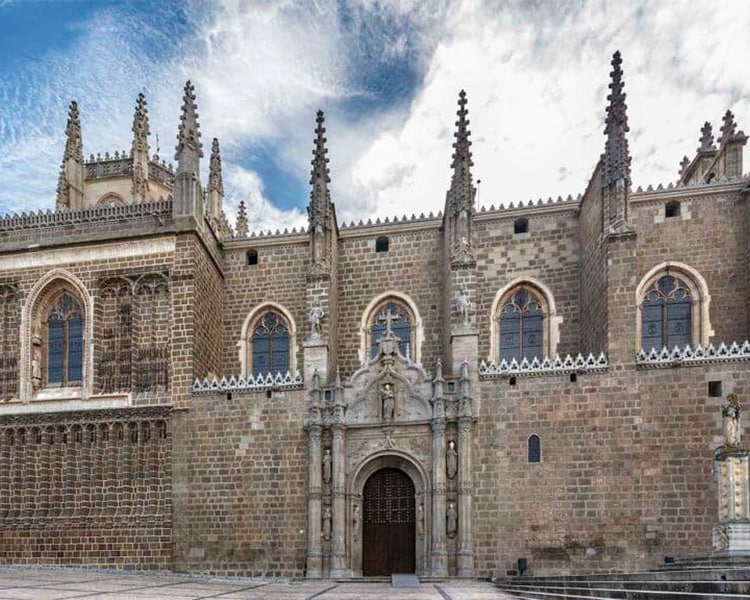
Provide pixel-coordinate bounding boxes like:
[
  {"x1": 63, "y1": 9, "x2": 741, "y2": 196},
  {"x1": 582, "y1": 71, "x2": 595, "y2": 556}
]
[{"x1": 362, "y1": 468, "x2": 415, "y2": 576}]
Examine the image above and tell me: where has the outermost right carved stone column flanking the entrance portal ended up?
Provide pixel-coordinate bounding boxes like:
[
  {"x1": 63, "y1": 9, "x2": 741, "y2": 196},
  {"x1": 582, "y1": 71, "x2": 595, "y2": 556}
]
[{"x1": 457, "y1": 417, "x2": 474, "y2": 577}]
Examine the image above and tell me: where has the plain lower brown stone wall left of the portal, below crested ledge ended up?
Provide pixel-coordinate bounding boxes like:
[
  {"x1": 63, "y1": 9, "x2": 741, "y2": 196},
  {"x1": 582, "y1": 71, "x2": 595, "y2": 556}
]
[{"x1": 174, "y1": 390, "x2": 308, "y2": 577}]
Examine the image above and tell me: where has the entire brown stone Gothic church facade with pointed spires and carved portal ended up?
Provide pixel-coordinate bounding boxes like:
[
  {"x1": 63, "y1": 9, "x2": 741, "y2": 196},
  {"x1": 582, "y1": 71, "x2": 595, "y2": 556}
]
[{"x1": 0, "y1": 55, "x2": 750, "y2": 577}]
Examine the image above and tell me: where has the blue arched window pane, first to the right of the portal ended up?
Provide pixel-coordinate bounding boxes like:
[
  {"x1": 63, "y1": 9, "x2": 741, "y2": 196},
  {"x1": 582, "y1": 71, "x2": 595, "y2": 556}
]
[{"x1": 498, "y1": 285, "x2": 544, "y2": 361}]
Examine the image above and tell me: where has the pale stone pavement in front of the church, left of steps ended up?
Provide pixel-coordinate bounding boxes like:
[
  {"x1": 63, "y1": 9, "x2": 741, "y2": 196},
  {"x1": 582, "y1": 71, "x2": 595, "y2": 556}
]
[{"x1": 0, "y1": 567, "x2": 511, "y2": 600}]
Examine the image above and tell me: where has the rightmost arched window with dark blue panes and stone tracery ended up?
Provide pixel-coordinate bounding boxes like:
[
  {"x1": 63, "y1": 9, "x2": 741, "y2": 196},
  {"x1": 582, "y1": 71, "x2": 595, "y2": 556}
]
[{"x1": 641, "y1": 275, "x2": 695, "y2": 350}]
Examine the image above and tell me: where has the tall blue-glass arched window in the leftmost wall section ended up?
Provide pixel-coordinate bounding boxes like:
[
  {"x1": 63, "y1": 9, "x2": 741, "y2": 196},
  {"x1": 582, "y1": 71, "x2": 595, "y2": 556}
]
[{"x1": 47, "y1": 292, "x2": 83, "y2": 386}]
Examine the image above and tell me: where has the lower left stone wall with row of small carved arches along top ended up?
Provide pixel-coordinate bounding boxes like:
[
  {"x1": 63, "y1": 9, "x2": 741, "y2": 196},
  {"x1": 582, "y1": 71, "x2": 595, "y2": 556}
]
[{"x1": 0, "y1": 408, "x2": 172, "y2": 569}]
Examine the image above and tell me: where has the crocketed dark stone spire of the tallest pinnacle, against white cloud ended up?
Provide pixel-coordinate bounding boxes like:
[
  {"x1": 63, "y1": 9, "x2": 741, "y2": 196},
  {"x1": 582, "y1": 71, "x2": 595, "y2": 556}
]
[{"x1": 604, "y1": 50, "x2": 631, "y2": 188}]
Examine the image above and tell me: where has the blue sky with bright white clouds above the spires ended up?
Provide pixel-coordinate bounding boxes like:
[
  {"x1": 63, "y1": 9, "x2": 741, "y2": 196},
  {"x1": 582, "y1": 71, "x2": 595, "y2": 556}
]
[{"x1": 0, "y1": 0, "x2": 750, "y2": 230}]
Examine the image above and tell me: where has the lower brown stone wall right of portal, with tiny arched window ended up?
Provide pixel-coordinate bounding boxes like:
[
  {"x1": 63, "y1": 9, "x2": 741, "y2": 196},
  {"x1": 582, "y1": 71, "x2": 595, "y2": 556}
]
[{"x1": 474, "y1": 363, "x2": 750, "y2": 576}]
